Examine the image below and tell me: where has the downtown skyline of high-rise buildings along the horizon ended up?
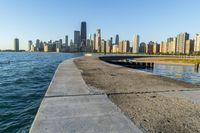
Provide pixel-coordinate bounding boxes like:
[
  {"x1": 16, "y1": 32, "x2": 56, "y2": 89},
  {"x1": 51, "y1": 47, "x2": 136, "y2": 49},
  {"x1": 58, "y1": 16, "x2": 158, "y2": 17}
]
[{"x1": 10, "y1": 22, "x2": 200, "y2": 55}]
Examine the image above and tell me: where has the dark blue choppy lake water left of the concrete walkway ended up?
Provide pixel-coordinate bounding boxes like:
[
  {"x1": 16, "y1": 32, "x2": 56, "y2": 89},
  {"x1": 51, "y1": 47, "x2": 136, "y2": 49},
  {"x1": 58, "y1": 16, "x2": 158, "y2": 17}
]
[{"x1": 0, "y1": 52, "x2": 81, "y2": 133}]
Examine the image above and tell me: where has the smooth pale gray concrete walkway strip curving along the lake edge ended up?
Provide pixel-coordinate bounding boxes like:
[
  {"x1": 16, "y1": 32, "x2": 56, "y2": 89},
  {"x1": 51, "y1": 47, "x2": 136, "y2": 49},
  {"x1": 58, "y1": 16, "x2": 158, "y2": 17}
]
[{"x1": 30, "y1": 59, "x2": 141, "y2": 133}]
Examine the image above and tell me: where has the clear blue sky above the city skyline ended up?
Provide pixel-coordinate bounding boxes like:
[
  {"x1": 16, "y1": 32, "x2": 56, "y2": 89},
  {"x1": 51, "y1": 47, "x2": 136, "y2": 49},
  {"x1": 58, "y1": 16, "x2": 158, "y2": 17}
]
[{"x1": 0, "y1": 0, "x2": 200, "y2": 49}]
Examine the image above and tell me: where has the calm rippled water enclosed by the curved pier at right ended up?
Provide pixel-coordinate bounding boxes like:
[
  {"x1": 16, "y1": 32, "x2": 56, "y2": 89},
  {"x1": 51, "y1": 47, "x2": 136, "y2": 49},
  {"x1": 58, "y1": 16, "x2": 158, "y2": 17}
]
[{"x1": 146, "y1": 64, "x2": 200, "y2": 84}]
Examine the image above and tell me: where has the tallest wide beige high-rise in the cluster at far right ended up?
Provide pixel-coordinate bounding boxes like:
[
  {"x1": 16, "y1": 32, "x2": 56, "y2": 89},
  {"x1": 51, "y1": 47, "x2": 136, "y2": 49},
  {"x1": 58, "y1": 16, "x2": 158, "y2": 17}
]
[{"x1": 176, "y1": 32, "x2": 189, "y2": 53}]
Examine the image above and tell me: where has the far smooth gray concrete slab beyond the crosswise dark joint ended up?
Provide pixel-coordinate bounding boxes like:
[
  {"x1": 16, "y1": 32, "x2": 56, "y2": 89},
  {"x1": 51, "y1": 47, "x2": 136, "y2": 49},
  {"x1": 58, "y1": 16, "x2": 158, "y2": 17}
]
[{"x1": 45, "y1": 59, "x2": 90, "y2": 96}]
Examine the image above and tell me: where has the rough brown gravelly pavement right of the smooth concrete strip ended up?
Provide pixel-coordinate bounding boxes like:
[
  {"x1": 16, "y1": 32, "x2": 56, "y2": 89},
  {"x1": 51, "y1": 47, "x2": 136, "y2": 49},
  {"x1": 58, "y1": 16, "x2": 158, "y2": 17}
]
[{"x1": 74, "y1": 57, "x2": 200, "y2": 133}]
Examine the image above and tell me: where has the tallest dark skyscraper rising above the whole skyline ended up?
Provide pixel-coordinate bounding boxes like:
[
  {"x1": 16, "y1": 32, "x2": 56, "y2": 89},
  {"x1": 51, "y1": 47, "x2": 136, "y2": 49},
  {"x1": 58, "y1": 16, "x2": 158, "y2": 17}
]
[{"x1": 81, "y1": 22, "x2": 87, "y2": 51}]
